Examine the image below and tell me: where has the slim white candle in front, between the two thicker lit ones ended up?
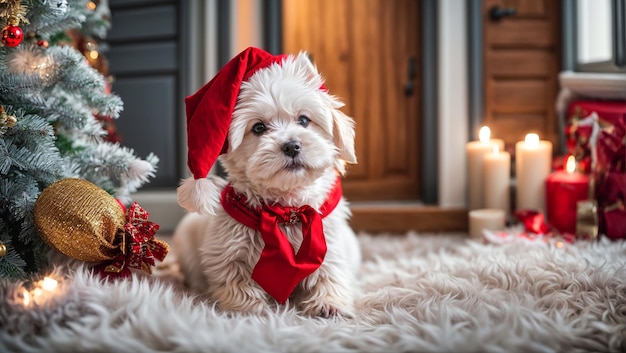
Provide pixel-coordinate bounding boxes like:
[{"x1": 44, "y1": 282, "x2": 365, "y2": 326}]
[{"x1": 483, "y1": 145, "x2": 511, "y2": 215}]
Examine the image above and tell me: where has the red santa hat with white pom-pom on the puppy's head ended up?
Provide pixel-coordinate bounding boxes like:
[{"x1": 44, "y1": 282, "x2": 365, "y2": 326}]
[{"x1": 178, "y1": 47, "x2": 285, "y2": 213}]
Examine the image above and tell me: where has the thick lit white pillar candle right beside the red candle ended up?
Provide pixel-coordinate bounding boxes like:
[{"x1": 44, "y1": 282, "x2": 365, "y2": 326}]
[{"x1": 515, "y1": 134, "x2": 552, "y2": 212}]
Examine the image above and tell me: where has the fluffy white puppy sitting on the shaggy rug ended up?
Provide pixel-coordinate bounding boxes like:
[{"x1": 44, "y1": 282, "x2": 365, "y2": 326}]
[{"x1": 173, "y1": 48, "x2": 361, "y2": 317}]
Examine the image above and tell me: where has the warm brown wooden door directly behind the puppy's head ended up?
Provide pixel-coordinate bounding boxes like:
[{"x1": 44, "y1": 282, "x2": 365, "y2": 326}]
[{"x1": 283, "y1": 0, "x2": 421, "y2": 200}]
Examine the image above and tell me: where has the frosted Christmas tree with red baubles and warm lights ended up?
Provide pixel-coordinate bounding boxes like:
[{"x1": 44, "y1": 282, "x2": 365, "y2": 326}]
[{"x1": 0, "y1": 0, "x2": 158, "y2": 279}]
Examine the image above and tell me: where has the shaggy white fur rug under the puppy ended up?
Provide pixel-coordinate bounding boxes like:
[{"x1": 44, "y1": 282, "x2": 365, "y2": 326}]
[{"x1": 0, "y1": 234, "x2": 626, "y2": 352}]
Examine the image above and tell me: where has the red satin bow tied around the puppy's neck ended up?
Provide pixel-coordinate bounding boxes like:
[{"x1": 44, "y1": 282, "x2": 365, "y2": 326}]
[{"x1": 221, "y1": 178, "x2": 342, "y2": 304}]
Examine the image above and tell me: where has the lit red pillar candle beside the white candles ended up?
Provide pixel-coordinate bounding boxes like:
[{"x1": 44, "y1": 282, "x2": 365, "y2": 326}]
[{"x1": 546, "y1": 156, "x2": 589, "y2": 234}]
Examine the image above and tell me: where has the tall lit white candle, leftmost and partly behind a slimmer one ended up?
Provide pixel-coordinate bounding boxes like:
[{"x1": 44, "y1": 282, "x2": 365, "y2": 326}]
[{"x1": 465, "y1": 126, "x2": 504, "y2": 210}]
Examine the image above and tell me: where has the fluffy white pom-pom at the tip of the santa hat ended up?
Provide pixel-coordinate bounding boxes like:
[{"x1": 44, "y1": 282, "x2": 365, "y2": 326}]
[{"x1": 176, "y1": 175, "x2": 227, "y2": 215}]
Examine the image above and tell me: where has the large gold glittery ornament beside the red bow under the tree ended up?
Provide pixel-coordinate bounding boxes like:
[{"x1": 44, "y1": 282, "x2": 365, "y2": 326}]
[{"x1": 34, "y1": 178, "x2": 126, "y2": 262}]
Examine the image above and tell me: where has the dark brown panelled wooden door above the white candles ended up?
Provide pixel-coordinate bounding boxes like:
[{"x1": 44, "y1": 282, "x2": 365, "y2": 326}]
[{"x1": 483, "y1": 0, "x2": 561, "y2": 148}]
